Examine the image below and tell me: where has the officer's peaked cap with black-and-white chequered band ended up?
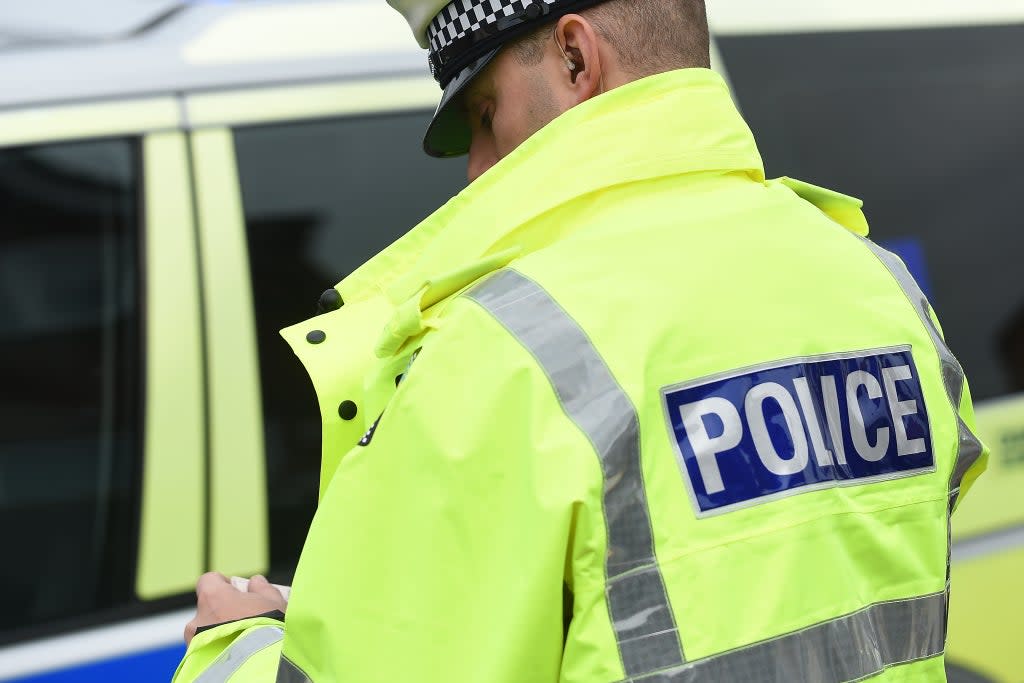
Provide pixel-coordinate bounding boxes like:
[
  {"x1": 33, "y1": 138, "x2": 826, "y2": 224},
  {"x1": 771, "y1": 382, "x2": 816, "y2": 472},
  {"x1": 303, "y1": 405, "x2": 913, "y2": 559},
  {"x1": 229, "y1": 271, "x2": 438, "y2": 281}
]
[{"x1": 388, "y1": 0, "x2": 604, "y2": 157}]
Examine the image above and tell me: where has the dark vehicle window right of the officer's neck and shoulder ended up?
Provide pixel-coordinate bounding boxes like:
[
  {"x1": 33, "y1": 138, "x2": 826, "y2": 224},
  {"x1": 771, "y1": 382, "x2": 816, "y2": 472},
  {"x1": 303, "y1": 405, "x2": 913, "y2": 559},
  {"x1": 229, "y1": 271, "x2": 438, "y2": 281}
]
[{"x1": 719, "y1": 26, "x2": 1024, "y2": 398}]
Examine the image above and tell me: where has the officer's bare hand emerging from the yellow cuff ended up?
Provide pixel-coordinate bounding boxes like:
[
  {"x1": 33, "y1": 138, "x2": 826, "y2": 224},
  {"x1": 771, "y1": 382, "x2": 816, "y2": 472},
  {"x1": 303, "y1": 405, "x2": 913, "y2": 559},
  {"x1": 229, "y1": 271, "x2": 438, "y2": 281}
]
[{"x1": 185, "y1": 571, "x2": 288, "y2": 645}]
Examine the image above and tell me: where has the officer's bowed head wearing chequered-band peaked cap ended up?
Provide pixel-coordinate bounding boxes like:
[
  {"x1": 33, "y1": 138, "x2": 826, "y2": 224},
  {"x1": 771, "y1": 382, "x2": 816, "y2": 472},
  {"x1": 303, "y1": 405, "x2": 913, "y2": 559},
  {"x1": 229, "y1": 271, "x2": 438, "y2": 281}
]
[{"x1": 388, "y1": 0, "x2": 710, "y2": 180}]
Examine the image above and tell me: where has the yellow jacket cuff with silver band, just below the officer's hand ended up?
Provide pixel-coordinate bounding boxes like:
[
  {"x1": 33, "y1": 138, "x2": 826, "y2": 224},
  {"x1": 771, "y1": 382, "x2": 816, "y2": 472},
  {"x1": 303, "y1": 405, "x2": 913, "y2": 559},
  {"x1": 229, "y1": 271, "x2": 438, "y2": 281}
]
[{"x1": 173, "y1": 616, "x2": 285, "y2": 683}]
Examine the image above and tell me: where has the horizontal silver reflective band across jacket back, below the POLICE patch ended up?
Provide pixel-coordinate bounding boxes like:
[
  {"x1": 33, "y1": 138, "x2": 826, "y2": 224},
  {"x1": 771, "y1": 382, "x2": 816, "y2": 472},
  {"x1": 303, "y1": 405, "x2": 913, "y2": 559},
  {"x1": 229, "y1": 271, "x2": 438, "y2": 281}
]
[{"x1": 629, "y1": 593, "x2": 946, "y2": 683}]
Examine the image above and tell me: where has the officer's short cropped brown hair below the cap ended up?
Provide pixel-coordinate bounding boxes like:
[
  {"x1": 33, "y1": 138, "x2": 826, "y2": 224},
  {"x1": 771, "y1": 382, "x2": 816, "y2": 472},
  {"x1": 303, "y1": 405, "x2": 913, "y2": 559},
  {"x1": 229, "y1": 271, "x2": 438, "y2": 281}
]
[{"x1": 510, "y1": 0, "x2": 711, "y2": 78}]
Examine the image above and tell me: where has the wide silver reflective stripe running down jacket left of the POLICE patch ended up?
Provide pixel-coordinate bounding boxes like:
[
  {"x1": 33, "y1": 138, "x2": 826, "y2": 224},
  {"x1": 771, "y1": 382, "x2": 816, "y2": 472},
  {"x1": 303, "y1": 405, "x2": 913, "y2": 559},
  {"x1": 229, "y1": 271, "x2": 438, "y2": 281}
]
[{"x1": 466, "y1": 269, "x2": 686, "y2": 677}]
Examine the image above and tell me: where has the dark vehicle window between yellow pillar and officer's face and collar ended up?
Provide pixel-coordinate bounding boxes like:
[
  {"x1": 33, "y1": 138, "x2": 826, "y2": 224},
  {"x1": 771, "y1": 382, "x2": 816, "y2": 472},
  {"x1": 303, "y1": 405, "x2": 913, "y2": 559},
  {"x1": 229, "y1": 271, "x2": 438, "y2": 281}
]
[{"x1": 234, "y1": 112, "x2": 466, "y2": 581}]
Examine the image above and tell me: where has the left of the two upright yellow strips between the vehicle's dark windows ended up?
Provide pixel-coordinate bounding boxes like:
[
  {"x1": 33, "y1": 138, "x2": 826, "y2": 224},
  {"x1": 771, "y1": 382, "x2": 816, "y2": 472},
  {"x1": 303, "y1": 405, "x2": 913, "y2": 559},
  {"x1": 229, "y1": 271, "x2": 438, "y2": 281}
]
[{"x1": 135, "y1": 132, "x2": 206, "y2": 600}]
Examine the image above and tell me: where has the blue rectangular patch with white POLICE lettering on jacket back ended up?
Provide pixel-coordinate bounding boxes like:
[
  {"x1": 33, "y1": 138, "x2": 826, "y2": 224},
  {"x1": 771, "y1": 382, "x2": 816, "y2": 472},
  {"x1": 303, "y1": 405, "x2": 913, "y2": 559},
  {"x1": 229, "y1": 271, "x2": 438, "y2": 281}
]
[{"x1": 663, "y1": 346, "x2": 935, "y2": 516}]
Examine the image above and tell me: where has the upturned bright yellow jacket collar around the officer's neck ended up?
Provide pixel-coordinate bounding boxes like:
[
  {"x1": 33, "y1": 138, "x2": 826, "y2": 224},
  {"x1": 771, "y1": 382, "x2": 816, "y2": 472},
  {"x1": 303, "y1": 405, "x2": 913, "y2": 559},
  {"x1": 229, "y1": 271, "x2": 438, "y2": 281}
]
[{"x1": 338, "y1": 69, "x2": 764, "y2": 303}]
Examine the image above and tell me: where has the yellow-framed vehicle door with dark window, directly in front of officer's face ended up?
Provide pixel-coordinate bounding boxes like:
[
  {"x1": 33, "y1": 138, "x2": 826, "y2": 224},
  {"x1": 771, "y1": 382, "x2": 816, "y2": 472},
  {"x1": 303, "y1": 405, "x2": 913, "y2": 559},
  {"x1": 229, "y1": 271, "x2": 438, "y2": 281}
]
[{"x1": 186, "y1": 74, "x2": 466, "y2": 584}]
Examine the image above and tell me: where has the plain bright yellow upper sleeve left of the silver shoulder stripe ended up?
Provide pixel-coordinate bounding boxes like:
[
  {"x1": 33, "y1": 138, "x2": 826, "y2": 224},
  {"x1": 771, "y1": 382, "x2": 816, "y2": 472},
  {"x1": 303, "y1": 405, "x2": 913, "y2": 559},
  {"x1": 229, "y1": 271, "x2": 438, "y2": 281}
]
[{"x1": 284, "y1": 299, "x2": 604, "y2": 683}]
